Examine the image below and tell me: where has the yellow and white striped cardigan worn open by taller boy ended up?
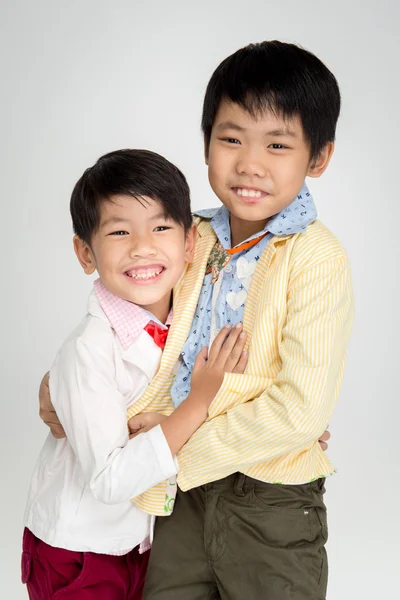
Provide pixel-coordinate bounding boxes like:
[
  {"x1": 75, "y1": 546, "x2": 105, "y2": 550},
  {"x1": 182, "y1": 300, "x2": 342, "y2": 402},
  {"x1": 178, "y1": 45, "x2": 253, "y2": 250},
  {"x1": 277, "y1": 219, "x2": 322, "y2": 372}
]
[{"x1": 128, "y1": 219, "x2": 353, "y2": 515}]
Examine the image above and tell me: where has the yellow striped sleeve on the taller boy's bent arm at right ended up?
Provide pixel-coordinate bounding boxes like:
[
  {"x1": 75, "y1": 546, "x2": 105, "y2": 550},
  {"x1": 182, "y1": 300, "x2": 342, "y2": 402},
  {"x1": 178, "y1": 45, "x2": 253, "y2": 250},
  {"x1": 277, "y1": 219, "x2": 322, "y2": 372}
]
[{"x1": 178, "y1": 256, "x2": 353, "y2": 474}]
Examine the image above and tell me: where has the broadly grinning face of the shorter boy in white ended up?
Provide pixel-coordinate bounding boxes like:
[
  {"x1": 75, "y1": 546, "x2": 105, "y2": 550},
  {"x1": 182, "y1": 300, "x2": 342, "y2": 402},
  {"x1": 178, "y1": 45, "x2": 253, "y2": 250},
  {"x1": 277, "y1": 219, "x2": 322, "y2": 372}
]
[{"x1": 74, "y1": 195, "x2": 195, "y2": 321}]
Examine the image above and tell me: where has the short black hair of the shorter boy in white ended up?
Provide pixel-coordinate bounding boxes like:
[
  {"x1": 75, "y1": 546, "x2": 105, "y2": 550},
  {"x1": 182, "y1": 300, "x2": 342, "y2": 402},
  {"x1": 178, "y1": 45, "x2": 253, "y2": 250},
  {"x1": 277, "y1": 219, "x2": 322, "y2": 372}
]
[{"x1": 70, "y1": 149, "x2": 192, "y2": 244}]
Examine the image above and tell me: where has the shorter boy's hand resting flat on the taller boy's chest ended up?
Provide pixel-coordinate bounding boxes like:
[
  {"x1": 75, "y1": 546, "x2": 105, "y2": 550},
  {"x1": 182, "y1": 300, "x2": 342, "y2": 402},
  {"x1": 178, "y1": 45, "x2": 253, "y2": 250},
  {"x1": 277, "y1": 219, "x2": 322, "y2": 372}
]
[{"x1": 190, "y1": 323, "x2": 248, "y2": 409}]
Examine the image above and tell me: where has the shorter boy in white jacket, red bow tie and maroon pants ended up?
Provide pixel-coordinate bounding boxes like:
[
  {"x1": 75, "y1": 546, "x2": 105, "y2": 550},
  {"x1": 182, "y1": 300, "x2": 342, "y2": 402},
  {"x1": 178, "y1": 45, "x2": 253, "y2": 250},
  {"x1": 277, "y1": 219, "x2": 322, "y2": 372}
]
[{"x1": 22, "y1": 150, "x2": 246, "y2": 600}]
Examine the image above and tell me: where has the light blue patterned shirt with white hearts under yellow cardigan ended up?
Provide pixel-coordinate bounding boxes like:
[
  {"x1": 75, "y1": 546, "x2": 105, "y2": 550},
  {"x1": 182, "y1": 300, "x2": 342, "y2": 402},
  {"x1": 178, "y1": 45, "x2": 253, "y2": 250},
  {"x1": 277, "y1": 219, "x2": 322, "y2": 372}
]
[{"x1": 171, "y1": 184, "x2": 317, "y2": 407}]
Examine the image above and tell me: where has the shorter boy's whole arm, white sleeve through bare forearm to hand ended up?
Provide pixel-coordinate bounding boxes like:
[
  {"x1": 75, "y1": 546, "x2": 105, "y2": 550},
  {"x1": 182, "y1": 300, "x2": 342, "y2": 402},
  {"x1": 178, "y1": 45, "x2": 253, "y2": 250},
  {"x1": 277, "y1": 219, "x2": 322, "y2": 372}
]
[{"x1": 50, "y1": 328, "x2": 247, "y2": 504}]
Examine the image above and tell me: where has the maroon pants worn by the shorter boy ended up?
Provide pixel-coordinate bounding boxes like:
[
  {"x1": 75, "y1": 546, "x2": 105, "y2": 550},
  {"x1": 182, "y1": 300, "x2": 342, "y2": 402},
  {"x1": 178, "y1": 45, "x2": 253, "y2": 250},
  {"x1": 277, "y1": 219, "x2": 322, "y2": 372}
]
[{"x1": 22, "y1": 529, "x2": 150, "y2": 600}]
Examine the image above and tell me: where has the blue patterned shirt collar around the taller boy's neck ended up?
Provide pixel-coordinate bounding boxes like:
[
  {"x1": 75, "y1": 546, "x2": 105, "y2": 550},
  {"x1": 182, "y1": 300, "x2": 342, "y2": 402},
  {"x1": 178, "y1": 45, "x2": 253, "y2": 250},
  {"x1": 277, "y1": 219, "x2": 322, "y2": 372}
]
[{"x1": 194, "y1": 183, "x2": 317, "y2": 250}]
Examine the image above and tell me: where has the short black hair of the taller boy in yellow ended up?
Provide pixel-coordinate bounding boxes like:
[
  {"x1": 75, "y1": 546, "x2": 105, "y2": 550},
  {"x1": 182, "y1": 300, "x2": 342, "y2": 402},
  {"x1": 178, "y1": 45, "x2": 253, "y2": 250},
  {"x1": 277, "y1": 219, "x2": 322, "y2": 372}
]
[{"x1": 201, "y1": 40, "x2": 340, "y2": 159}]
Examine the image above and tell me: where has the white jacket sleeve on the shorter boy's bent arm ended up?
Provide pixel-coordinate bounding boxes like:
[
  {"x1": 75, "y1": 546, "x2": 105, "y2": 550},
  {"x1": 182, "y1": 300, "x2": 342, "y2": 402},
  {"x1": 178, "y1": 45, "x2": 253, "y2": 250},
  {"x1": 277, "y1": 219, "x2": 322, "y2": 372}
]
[{"x1": 50, "y1": 339, "x2": 176, "y2": 504}]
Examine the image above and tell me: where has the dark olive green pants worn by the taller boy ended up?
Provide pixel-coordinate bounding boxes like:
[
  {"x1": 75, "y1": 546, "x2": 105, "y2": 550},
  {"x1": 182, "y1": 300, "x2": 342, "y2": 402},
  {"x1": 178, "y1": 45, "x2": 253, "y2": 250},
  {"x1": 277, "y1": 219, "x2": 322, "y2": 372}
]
[{"x1": 143, "y1": 473, "x2": 328, "y2": 600}]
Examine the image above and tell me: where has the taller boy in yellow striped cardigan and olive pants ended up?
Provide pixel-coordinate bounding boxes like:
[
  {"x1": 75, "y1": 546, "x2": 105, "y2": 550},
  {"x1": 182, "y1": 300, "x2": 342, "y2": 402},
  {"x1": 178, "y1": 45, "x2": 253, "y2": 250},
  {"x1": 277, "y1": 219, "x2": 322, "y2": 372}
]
[{"x1": 138, "y1": 41, "x2": 352, "y2": 600}]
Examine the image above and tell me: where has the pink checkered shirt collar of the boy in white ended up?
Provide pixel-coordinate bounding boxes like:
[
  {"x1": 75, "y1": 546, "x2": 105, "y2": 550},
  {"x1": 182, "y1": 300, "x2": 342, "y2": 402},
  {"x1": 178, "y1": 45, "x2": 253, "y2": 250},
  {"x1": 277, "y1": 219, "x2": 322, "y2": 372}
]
[{"x1": 94, "y1": 279, "x2": 172, "y2": 350}]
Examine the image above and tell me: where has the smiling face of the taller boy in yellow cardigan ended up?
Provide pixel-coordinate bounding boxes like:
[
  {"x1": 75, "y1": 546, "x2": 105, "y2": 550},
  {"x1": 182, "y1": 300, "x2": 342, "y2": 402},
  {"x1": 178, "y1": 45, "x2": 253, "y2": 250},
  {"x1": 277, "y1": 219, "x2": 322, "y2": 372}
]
[{"x1": 206, "y1": 101, "x2": 333, "y2": 245}]
